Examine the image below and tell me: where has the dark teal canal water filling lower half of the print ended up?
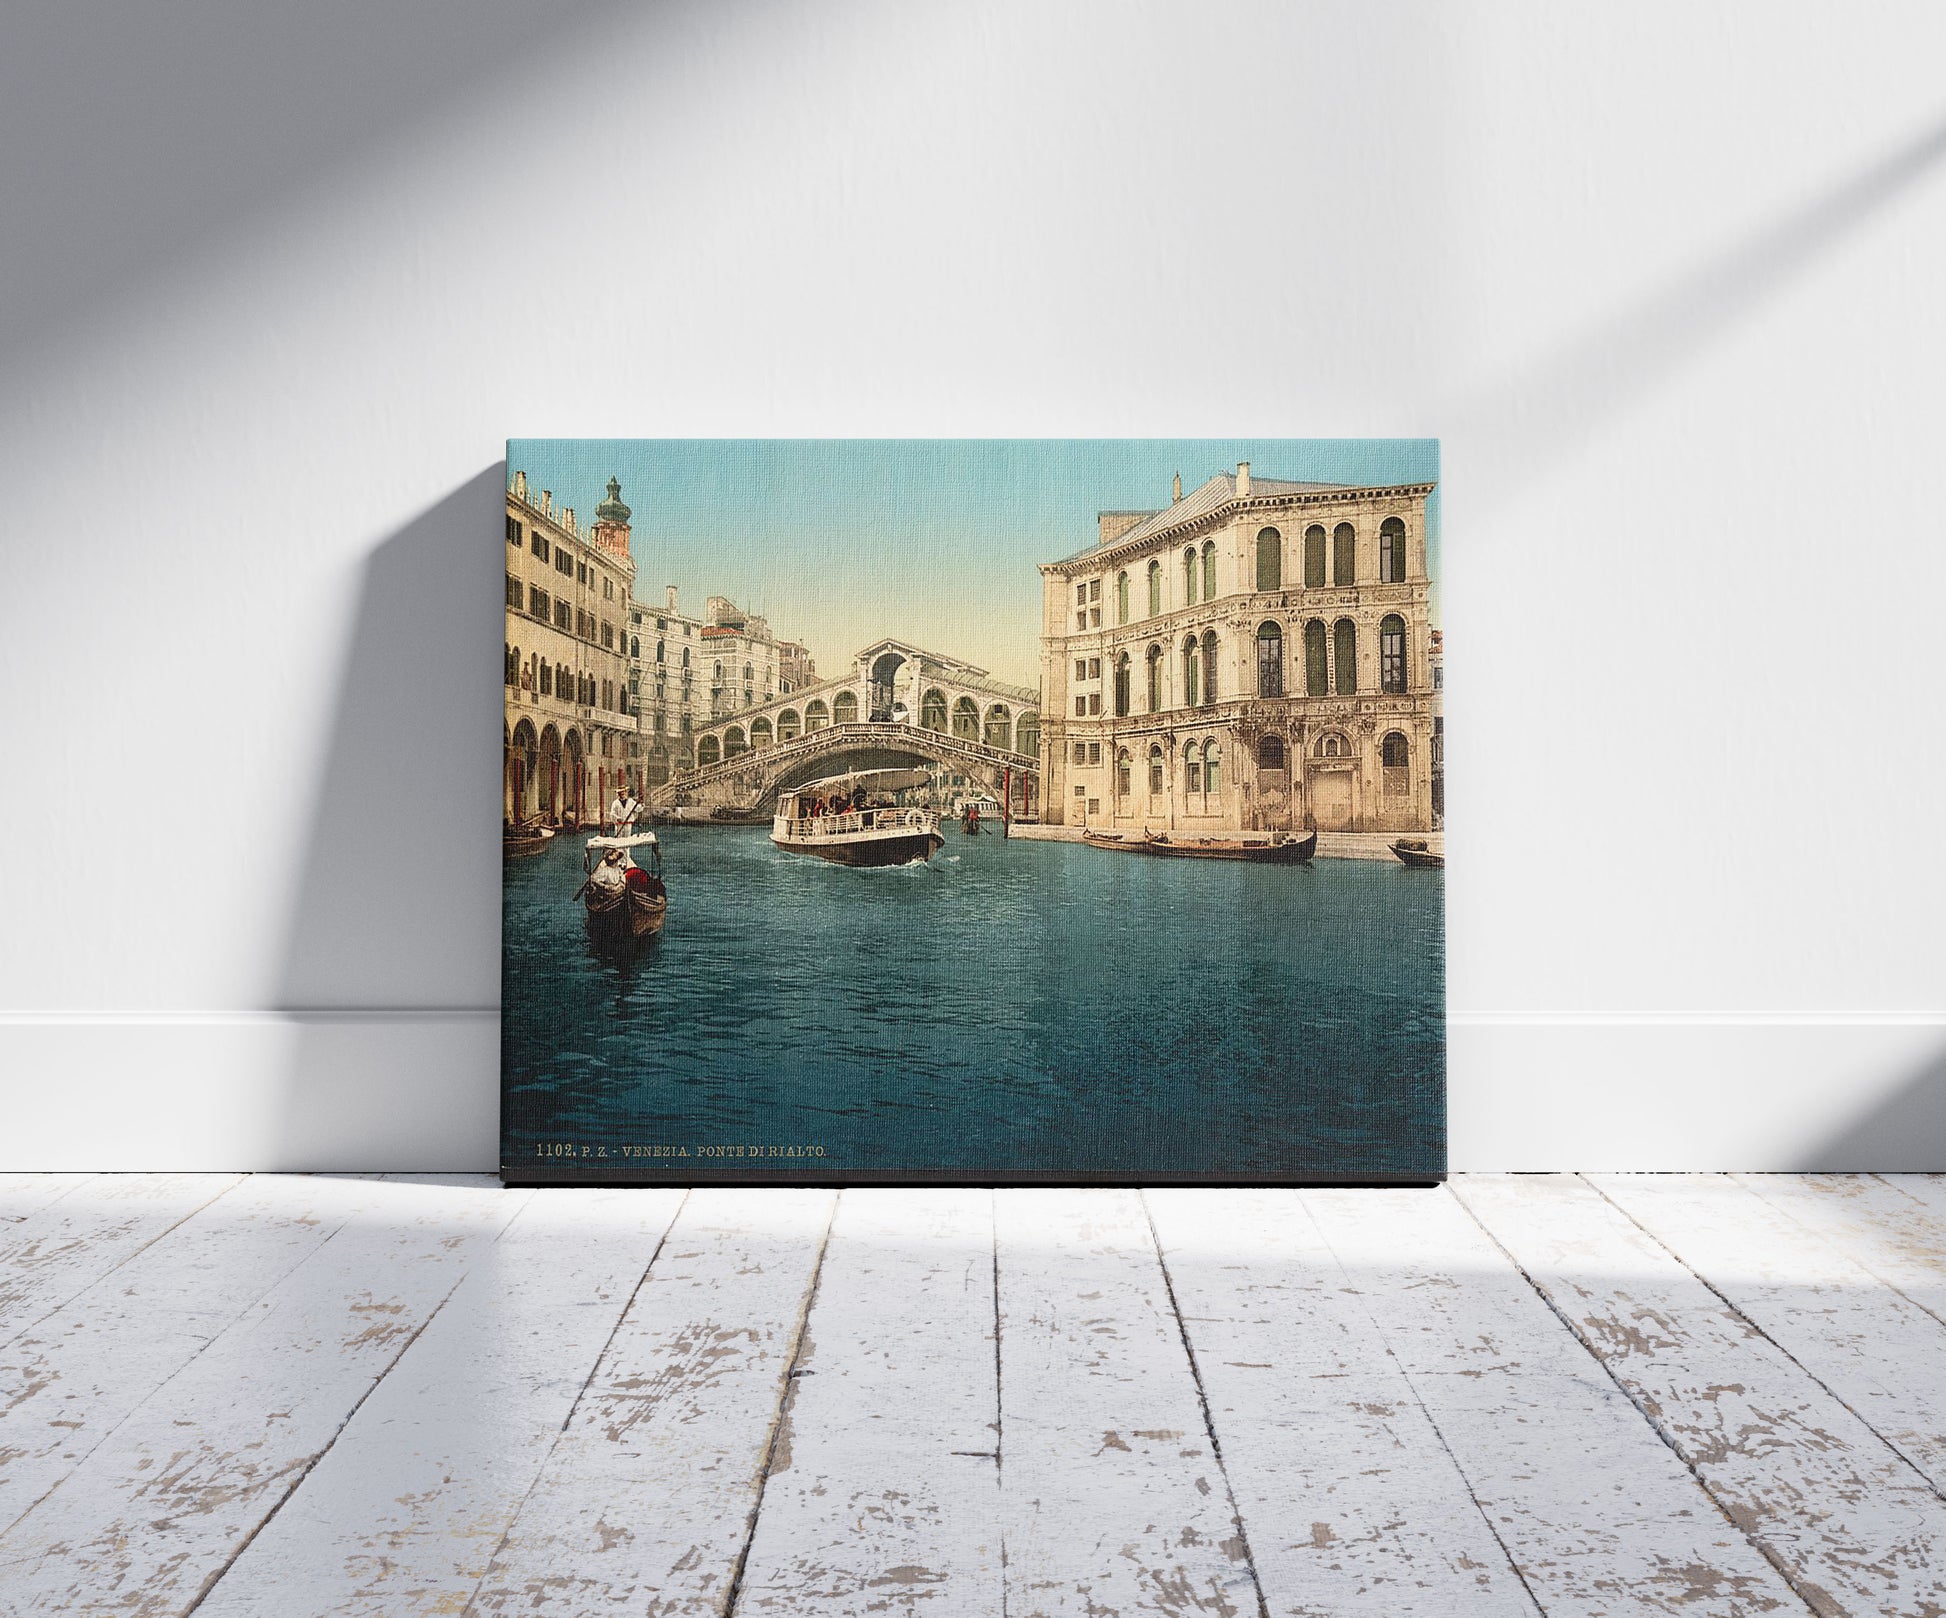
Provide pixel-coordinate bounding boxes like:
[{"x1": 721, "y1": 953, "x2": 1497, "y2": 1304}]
[{"x1": 502, "y1": 826, "x2": 1446, "y2": 1178}]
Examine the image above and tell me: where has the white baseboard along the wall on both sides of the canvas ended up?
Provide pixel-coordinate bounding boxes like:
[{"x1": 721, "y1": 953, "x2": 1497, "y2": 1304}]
[{"x1": 0, "y1": 1011, "x2": 1946, "y2": 1172}]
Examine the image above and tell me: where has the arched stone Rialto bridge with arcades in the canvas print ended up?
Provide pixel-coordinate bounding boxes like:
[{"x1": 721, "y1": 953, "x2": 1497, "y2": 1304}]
[{"x1": 650, "y1": 641, "x2": 1041, "y2": 814}]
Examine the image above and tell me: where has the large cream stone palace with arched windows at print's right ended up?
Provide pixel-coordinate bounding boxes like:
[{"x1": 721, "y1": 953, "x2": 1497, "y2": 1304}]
[{"x1": 1041, "y1": 461, "x2": 1438, "y2": 831}]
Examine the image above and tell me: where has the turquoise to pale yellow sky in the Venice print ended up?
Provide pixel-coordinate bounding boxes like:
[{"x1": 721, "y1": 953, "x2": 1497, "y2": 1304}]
[{"x1": 506, "y1": 438, "x2": 1440, "y2": 685}]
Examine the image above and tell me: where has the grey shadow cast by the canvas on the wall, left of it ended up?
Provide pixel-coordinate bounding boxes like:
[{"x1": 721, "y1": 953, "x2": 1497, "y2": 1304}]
[{"x1": 272, "y1": 475, "x2": 506, "y2": 1168}]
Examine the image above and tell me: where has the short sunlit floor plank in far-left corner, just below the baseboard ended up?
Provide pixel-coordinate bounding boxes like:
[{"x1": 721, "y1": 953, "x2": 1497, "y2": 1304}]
[{"x1": 0, "y1": 1174, "x2": 243, "y2": 1347}]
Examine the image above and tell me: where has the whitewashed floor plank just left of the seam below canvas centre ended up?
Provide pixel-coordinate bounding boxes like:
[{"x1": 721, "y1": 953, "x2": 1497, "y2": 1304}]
[{"x1": 736, "y1": 1190, "x2": 1000, "y2": 1618}]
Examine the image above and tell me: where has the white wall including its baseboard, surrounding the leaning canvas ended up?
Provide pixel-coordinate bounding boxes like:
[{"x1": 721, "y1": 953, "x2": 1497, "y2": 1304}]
[{"x1": 0, "y1": 0, "x2": 1946, "y2": 1168}]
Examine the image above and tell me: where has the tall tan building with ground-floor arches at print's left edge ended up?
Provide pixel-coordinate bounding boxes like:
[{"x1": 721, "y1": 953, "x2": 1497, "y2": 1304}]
[{"x1": 500, "y1": 471, "x2": 642, "y2": 826}]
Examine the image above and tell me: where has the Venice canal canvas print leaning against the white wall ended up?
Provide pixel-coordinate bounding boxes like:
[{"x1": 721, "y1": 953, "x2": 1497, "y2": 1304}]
[{"x1": 502, "y1": 438, "x2": 1446, "y2": 1184}]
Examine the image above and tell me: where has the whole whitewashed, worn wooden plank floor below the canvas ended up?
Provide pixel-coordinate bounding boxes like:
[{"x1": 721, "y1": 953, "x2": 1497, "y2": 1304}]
[{"x1": 0, "y1": 1174, "x2": 1946, "y2": 1618}]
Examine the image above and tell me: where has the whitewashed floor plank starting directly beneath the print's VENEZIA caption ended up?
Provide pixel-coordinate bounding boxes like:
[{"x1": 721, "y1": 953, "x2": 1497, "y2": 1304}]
[{"x1": 197, "y1": 1188, "x2": 683, "y2": 1618}]
